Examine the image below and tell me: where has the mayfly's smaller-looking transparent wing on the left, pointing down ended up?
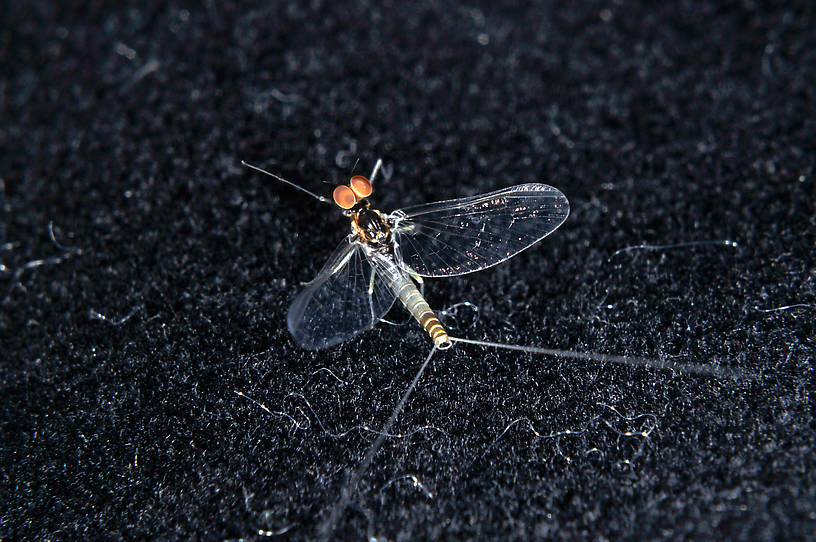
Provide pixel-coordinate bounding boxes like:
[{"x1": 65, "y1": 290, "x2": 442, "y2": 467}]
[{"x1": 287, "y1": 238, "x2": 395, "y2": 350}]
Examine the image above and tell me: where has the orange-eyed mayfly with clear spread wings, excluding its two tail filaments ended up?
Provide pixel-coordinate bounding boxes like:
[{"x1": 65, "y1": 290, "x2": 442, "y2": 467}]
[{"x1": 244, "y1": 162, "x2": 569, "y2": 350}]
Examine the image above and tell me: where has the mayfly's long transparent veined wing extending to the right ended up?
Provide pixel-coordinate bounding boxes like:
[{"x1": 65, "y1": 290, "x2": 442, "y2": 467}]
[{"x1": 389, "y1": 184, "x2": 569, "y2": 277}]
